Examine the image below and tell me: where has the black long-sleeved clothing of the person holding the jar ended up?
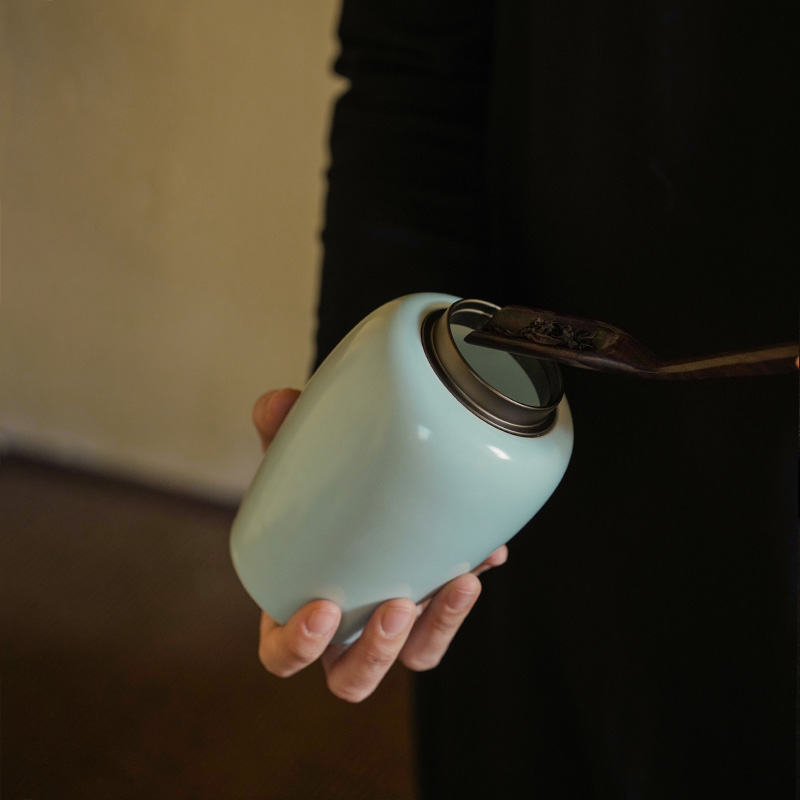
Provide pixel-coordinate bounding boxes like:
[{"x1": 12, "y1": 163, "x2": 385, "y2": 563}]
[{"x1": 318, "y1": 0, "x2": 799, "y2": 800}]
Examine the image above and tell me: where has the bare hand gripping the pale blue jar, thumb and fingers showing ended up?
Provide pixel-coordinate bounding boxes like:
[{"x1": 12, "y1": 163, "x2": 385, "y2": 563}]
[{"x1": 253, "y1": 389, "x2": 508, "y2": 703}]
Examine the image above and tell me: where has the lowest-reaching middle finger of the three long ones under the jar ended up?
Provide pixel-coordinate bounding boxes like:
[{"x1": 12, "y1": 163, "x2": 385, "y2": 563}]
[{"x1": 322, "y1": 599, "x2": 417, "y2": 703}]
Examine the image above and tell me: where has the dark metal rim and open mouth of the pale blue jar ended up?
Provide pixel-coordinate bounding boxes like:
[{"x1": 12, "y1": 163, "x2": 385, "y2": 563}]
[{"x1": 422, "y1": 300, "x2": 564, "y2": 437}]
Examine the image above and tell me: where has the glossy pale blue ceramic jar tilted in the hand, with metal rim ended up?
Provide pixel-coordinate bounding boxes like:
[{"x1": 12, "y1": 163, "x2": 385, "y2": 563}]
[{"x1": 231, "y1": 293, "x2": 573, "y2": 643}]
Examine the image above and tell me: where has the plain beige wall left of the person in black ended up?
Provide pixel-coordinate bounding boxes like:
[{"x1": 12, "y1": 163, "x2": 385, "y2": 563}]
[{"x1": 0, "y1": 0, "x2": 341, "y2": 496}]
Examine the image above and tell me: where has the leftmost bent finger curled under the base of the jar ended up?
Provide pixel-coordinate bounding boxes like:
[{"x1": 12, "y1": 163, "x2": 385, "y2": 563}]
[{"x1": 258, "y1": 600, "x2": 342, "y2": 678}]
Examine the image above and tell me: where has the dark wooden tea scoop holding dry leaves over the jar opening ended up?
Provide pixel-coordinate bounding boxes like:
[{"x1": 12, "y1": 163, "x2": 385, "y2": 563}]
[{"x1": 465, "y1": 306, "x2": 798, "y2": 380}]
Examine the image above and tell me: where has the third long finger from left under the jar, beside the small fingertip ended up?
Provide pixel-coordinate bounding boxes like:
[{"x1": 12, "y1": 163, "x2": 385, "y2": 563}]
[{"x1": 400, "y1": 567, "x2": 488, "y2": 672}]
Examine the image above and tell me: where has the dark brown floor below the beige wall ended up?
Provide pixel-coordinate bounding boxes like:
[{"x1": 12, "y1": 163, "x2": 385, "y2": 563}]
[{"x1": 0, "y1": 457, "x2": 414, "y2": 800}]
